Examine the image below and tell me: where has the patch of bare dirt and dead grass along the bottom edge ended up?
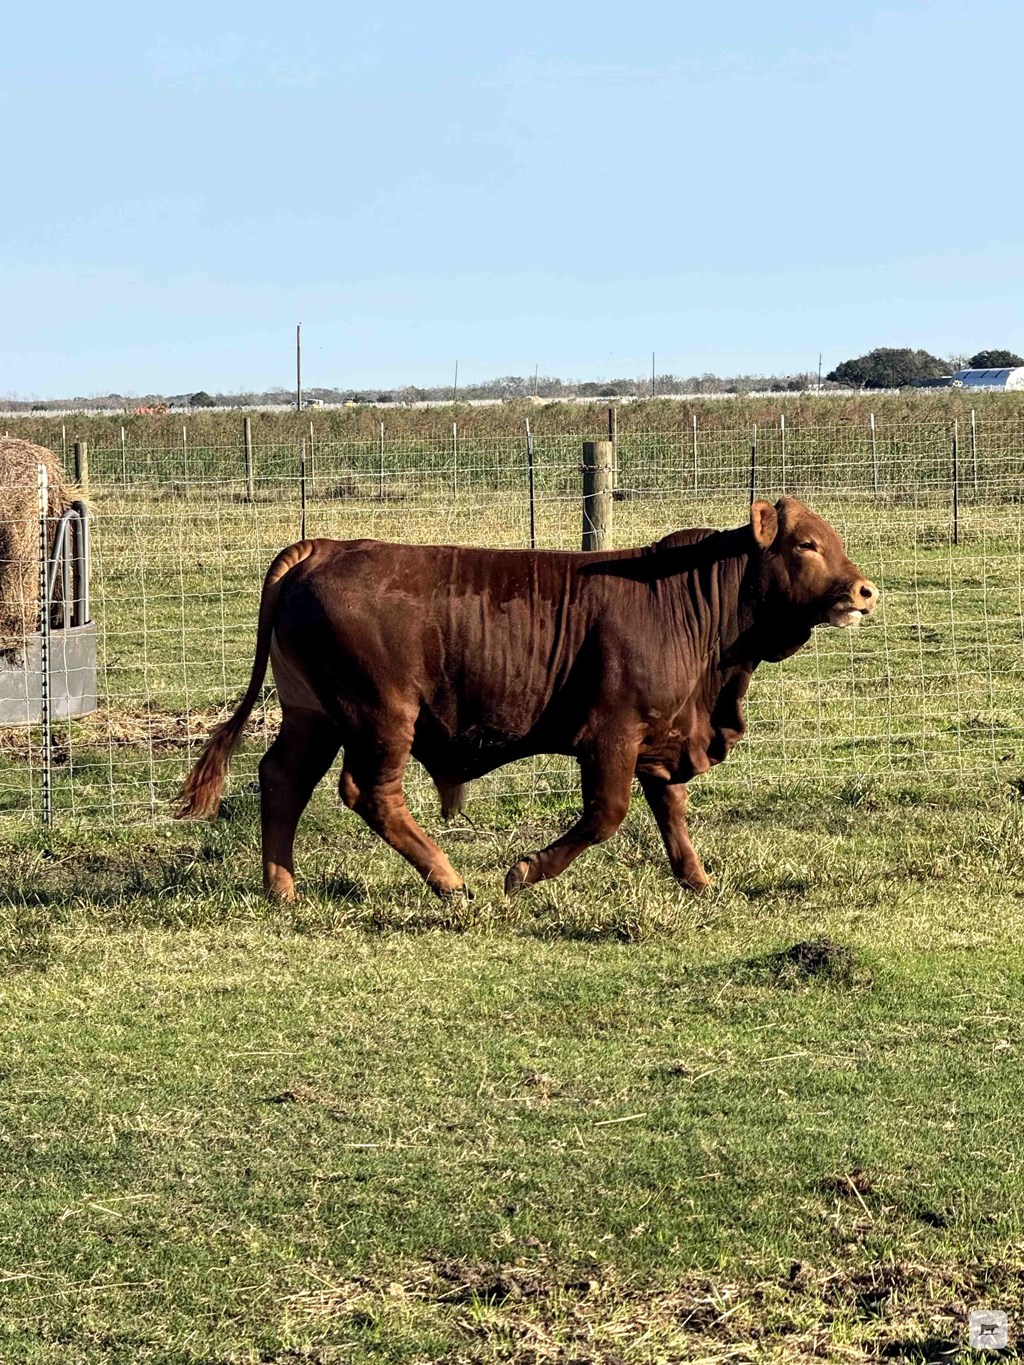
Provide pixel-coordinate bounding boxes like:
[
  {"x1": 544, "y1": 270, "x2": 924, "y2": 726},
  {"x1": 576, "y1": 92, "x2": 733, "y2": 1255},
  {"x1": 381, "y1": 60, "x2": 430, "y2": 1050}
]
[{"x1": 289, "y1": 1253, "x2": 1024, "y2": 1365}]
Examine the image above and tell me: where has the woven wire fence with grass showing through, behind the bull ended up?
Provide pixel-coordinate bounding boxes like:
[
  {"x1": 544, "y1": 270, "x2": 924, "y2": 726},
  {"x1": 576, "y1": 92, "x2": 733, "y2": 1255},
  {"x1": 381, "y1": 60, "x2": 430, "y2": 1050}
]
[{"x1": 0, "y1": 409, "x2": 1024, "y2": 822}]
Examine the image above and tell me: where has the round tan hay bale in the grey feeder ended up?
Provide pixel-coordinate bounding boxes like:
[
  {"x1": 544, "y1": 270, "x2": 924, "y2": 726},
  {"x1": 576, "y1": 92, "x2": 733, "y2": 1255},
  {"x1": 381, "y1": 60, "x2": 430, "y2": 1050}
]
[{"x1": 0, "y1": 435, "x2": 74, "y2": 662}]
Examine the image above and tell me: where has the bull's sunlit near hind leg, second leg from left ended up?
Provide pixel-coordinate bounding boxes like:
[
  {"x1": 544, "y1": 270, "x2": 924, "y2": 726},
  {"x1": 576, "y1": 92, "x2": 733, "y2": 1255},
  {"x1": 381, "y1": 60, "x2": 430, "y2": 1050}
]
[{"x1": 339, "y1": 740, "x2": 468, "y2": 895}]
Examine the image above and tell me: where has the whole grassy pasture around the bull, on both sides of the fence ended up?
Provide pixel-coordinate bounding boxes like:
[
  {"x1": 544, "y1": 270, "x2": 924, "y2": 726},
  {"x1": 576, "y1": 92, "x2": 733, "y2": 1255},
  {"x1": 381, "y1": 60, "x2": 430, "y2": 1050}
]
[{"x1": 0, "y1": 420, "x2": 1024, "y2": 1365}]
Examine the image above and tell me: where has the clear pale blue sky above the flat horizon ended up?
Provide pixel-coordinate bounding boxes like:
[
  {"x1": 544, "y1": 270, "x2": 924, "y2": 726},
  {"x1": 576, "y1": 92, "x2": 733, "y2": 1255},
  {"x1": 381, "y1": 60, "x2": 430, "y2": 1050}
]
[{"x1": 0, "y1": 0, "x2": 1024, "y2": 397}]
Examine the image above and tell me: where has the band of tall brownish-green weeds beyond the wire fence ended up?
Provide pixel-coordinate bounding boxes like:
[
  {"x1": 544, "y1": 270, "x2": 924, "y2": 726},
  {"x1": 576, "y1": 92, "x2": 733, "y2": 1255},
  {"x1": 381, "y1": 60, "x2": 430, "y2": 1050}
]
[{"x1": 54, "y1": 414, "x2": 1021, "y2": 510}]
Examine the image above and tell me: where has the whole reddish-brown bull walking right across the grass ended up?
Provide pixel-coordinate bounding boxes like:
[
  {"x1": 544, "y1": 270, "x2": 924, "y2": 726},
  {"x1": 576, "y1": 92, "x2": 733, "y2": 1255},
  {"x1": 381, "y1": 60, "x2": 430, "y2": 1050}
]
[{"x1": 177, "y1": 498, "x2": 878, "y2": 900}]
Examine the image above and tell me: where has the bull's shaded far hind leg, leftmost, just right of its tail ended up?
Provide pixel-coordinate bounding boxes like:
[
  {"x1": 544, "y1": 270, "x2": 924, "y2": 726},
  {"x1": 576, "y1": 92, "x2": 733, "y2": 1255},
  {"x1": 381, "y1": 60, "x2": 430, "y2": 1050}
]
[{"x1": 259, "y1": 707, "x2": 341, "y2": 901}]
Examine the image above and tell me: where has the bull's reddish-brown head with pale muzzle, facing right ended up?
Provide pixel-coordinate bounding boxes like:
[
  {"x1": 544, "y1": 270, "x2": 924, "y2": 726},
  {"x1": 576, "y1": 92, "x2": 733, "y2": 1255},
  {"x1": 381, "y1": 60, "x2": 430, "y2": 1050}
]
[{"x1": 750, "y1": 498, "x2": 878, "y2": 658}]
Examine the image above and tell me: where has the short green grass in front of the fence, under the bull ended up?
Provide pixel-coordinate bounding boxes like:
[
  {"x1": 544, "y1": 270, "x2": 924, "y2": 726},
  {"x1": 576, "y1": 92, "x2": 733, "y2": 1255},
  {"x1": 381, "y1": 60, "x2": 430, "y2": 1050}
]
[{"x1": 0, "y1": 786, "x2": 1024, "y2": 1365}]
